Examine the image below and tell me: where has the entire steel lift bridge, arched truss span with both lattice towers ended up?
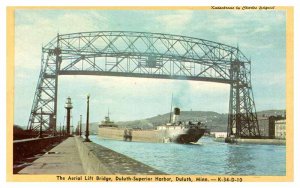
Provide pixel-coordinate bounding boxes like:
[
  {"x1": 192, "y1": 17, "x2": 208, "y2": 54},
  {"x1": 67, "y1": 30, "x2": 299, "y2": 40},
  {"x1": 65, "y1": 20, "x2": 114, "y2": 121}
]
[{"x1": 27, "y1": 31, "x2": 260, "y2": 138}]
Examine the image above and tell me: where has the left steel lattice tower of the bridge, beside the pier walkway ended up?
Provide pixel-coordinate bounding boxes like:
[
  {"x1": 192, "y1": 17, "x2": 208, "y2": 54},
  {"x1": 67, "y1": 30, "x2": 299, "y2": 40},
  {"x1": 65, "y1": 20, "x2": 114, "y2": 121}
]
[{"x1": 27, "y1": 35, "x2": 62, "y2": 134}]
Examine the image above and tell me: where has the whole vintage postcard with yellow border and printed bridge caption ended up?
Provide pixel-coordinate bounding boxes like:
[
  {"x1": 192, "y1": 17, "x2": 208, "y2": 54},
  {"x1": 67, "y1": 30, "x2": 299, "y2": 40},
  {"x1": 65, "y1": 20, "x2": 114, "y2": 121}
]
[{"x1": 7, "y1": 6, "x2": 294, "y2": 182}]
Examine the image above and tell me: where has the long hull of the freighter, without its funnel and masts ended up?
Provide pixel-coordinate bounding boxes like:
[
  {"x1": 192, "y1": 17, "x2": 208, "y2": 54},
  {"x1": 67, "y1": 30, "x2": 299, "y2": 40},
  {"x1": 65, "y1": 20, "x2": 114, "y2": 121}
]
[{"x1": 98, "y1": 126, "x2": 205, "y2": 144}]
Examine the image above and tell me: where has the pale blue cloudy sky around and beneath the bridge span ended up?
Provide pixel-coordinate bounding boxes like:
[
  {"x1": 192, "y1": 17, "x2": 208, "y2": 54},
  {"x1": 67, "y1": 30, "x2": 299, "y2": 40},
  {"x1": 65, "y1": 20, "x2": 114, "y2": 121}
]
[{"x1": 14, "y1": 9, "x2": 286, "y2": 126}]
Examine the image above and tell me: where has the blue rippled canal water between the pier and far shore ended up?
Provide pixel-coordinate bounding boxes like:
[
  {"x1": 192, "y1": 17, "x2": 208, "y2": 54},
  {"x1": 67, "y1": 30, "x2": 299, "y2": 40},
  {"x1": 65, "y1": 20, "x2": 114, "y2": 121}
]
[{"x1": 90, "y1": 135, "x2": 286, "y2": 176}]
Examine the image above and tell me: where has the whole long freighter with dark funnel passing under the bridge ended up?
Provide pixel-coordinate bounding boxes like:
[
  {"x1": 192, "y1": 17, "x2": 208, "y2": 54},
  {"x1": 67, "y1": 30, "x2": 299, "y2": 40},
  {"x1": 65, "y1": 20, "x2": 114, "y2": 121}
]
[{"x1": 98, "y1": 108, "x2": 206, "y2": 144}]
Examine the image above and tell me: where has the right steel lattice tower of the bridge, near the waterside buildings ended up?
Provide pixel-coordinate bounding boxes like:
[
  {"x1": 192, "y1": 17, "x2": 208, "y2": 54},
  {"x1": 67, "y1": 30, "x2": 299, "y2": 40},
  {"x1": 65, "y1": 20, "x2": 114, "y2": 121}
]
[{"x1": 227, "y1": 60, "x2": 260, "y2": 138}]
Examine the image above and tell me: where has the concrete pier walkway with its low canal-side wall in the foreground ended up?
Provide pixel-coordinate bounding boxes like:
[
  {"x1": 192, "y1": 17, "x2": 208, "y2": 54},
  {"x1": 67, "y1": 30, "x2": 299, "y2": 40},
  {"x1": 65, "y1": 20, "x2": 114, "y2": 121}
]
[{"x1": 19, "y1": 137, "x2": 165, "y2": 175}]
